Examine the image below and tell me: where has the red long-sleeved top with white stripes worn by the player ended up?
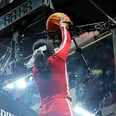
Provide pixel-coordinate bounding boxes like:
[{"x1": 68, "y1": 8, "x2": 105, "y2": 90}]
[{"x1": 32, "y1": 26, "x2": 71, "y2": 100}]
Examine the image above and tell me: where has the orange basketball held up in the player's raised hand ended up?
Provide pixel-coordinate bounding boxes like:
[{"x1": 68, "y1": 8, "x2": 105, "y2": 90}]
[{"x1": 46, "y1": 12, "x2": 71, "y2": 31}]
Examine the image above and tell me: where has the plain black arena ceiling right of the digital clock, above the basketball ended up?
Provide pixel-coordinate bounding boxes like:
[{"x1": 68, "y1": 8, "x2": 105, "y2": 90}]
[{"x1": 53, "y1": 0, "x2": 116, "y2": 25}]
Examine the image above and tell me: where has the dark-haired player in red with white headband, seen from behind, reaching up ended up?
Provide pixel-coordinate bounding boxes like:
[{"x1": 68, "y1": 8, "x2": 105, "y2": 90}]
[{"x1": 32, "y1": 20, "x2": 73, "y2": 116}]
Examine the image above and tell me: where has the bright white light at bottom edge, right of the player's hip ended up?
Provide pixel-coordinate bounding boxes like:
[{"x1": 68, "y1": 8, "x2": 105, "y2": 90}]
[{"x1": 74, "y1": 106, "x2": 95, "y2": 116}]
